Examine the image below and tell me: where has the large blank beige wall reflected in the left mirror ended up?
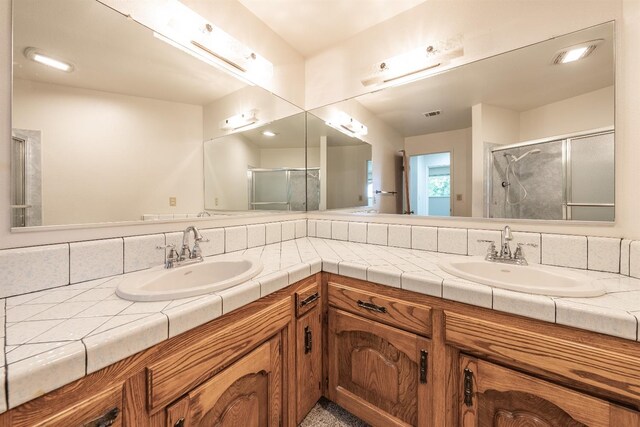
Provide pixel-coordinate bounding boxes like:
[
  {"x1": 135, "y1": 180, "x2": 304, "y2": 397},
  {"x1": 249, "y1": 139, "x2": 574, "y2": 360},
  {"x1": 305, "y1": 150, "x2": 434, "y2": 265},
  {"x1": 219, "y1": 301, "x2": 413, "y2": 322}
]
[{"x1": 13, "y1": 79, "x2": 203, "y2": 225}]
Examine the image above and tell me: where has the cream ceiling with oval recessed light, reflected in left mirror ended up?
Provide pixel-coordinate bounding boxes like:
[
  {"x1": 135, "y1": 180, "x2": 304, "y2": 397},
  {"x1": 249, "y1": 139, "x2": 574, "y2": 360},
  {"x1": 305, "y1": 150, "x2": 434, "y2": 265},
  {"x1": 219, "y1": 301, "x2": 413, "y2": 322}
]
[{"x1": 13, "y1": 0, "x2": 247, "y2": 105}]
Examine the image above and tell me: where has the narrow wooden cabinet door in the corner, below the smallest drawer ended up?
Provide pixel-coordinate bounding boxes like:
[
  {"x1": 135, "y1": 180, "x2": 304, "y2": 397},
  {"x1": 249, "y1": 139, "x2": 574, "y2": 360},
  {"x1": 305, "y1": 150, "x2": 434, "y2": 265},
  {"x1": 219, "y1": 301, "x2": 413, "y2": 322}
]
[{"x1": 296, "y1": 306, "x2": 322, "y2": 424}]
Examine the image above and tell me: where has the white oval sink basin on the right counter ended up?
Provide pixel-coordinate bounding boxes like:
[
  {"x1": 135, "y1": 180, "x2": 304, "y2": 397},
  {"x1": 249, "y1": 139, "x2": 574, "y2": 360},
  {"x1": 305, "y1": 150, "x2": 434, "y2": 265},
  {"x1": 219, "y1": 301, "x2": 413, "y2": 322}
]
[{"x1": 438, "y1": 257, "x2": 604, "y2": 297}]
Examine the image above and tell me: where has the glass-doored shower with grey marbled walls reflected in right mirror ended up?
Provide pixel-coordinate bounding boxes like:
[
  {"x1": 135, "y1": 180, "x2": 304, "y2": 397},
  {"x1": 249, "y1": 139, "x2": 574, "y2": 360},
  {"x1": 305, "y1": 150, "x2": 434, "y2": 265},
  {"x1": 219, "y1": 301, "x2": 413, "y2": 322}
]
[{"x1": 486, "y1": 130, "x2": 615, "y2": 221}]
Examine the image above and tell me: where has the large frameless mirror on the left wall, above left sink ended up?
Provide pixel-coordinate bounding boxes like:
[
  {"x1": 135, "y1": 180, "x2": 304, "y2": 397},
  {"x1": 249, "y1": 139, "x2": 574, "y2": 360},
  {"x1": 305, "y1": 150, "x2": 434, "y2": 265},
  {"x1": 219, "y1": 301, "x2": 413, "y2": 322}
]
[{"x1": 7, "y1": 0, "x2": 305, "y2": 227}]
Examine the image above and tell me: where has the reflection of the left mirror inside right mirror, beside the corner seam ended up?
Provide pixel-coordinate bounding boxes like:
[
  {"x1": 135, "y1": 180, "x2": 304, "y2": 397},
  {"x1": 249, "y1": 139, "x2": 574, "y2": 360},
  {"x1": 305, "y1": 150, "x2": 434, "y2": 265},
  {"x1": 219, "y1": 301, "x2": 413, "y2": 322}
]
[{"x1": 307, "y1": 112, "x2": 373, "y2": 212}]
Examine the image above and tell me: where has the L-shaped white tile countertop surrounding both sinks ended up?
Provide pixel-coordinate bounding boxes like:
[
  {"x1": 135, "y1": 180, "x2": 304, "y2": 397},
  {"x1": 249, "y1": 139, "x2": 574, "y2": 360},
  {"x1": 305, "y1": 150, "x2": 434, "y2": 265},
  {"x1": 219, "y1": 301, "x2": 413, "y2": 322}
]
[{"x1": 0, "y1": 238, "x2": 640, "y2": 412}]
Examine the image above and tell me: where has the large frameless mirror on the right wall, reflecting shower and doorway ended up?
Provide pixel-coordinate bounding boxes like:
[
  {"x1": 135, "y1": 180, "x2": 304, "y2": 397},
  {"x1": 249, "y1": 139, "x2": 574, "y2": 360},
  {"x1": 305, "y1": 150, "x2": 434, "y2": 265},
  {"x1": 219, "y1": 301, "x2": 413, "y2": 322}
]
[{"x1": 310, "y1": 22, "x2": 615, "y2": 221}]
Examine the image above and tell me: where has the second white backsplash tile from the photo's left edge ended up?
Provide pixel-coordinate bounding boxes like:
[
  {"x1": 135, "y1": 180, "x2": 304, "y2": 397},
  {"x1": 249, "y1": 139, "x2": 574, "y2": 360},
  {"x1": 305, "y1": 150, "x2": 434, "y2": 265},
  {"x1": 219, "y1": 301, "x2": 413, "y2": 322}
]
[{"x1": 69, "y1": 238, "x2": 124, "y2": 283}]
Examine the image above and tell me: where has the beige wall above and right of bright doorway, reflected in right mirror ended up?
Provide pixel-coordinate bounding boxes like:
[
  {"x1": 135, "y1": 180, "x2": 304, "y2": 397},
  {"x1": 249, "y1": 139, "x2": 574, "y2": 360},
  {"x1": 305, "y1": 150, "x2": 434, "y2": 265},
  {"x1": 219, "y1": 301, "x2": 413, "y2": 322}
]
[{"x1": 404, "y1": 128, "x2": 471, "y2": 216}]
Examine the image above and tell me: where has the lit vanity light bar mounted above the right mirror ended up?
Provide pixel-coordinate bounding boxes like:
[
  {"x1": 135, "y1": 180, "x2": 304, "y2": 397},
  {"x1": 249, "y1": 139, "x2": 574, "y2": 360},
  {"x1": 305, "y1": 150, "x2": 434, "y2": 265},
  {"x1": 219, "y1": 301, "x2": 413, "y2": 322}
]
[{"x1": 361, "y1": 36, "x2": 464, "y2": 86}]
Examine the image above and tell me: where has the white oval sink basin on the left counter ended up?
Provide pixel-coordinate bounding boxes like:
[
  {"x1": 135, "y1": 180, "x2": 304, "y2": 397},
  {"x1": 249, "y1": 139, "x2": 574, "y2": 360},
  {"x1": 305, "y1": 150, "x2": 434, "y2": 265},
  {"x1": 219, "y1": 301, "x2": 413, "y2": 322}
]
[{"x1": 116, "y1": 256, "x2": 262, "y2": 301}]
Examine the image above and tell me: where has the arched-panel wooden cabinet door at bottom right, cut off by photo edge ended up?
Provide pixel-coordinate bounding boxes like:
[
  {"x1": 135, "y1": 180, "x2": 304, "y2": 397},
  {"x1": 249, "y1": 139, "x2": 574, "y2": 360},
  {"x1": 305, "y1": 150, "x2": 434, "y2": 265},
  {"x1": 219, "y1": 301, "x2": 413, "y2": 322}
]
[{"x1": 460, "y1": 356, "x2": 640, "y2": 427}]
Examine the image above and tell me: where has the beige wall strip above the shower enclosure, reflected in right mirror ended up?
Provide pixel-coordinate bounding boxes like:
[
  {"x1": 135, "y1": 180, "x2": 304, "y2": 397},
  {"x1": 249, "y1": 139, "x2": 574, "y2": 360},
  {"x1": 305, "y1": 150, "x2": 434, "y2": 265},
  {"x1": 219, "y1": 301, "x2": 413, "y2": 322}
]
[{"x1": 519, "y1": 86, "x2": 614, "y2": 142}]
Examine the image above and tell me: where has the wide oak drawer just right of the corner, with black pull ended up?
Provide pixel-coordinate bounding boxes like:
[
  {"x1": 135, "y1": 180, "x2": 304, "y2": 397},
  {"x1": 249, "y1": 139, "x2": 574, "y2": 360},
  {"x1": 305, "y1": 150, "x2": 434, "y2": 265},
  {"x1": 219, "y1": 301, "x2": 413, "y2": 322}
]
[{"x1": 328, "y1": 283, "x2": 431, "y2": 336}]
